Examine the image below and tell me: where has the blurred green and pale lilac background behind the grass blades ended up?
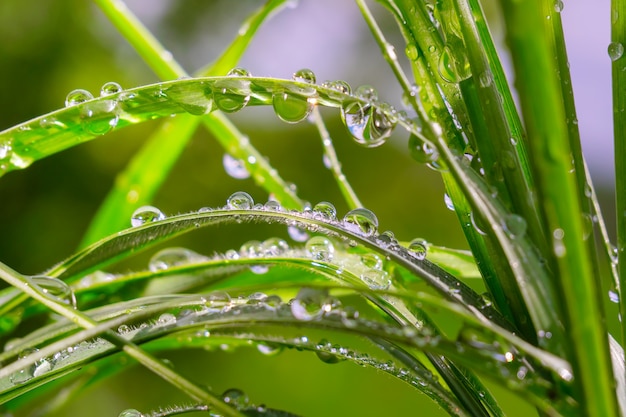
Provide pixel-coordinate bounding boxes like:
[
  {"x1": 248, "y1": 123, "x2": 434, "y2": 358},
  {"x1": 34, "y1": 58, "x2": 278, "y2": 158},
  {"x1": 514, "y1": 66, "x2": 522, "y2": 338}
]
[{"x1": 0, "y1": 0, "x2": 614, "y2": 417}]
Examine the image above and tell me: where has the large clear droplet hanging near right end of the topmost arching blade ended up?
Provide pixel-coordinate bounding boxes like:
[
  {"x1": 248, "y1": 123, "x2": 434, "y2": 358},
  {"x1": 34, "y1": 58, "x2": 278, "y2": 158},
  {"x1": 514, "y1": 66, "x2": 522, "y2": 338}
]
[{"x1": 341, "y1": 101, "x2": 395, "y2": 148}]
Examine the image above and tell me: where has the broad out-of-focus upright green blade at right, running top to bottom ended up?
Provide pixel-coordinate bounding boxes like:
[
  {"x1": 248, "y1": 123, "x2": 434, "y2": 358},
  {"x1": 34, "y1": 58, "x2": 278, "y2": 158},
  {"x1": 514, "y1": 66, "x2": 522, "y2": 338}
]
[{"x1": 503, "y1": 0, "x2": 617, "y2": 415}]
